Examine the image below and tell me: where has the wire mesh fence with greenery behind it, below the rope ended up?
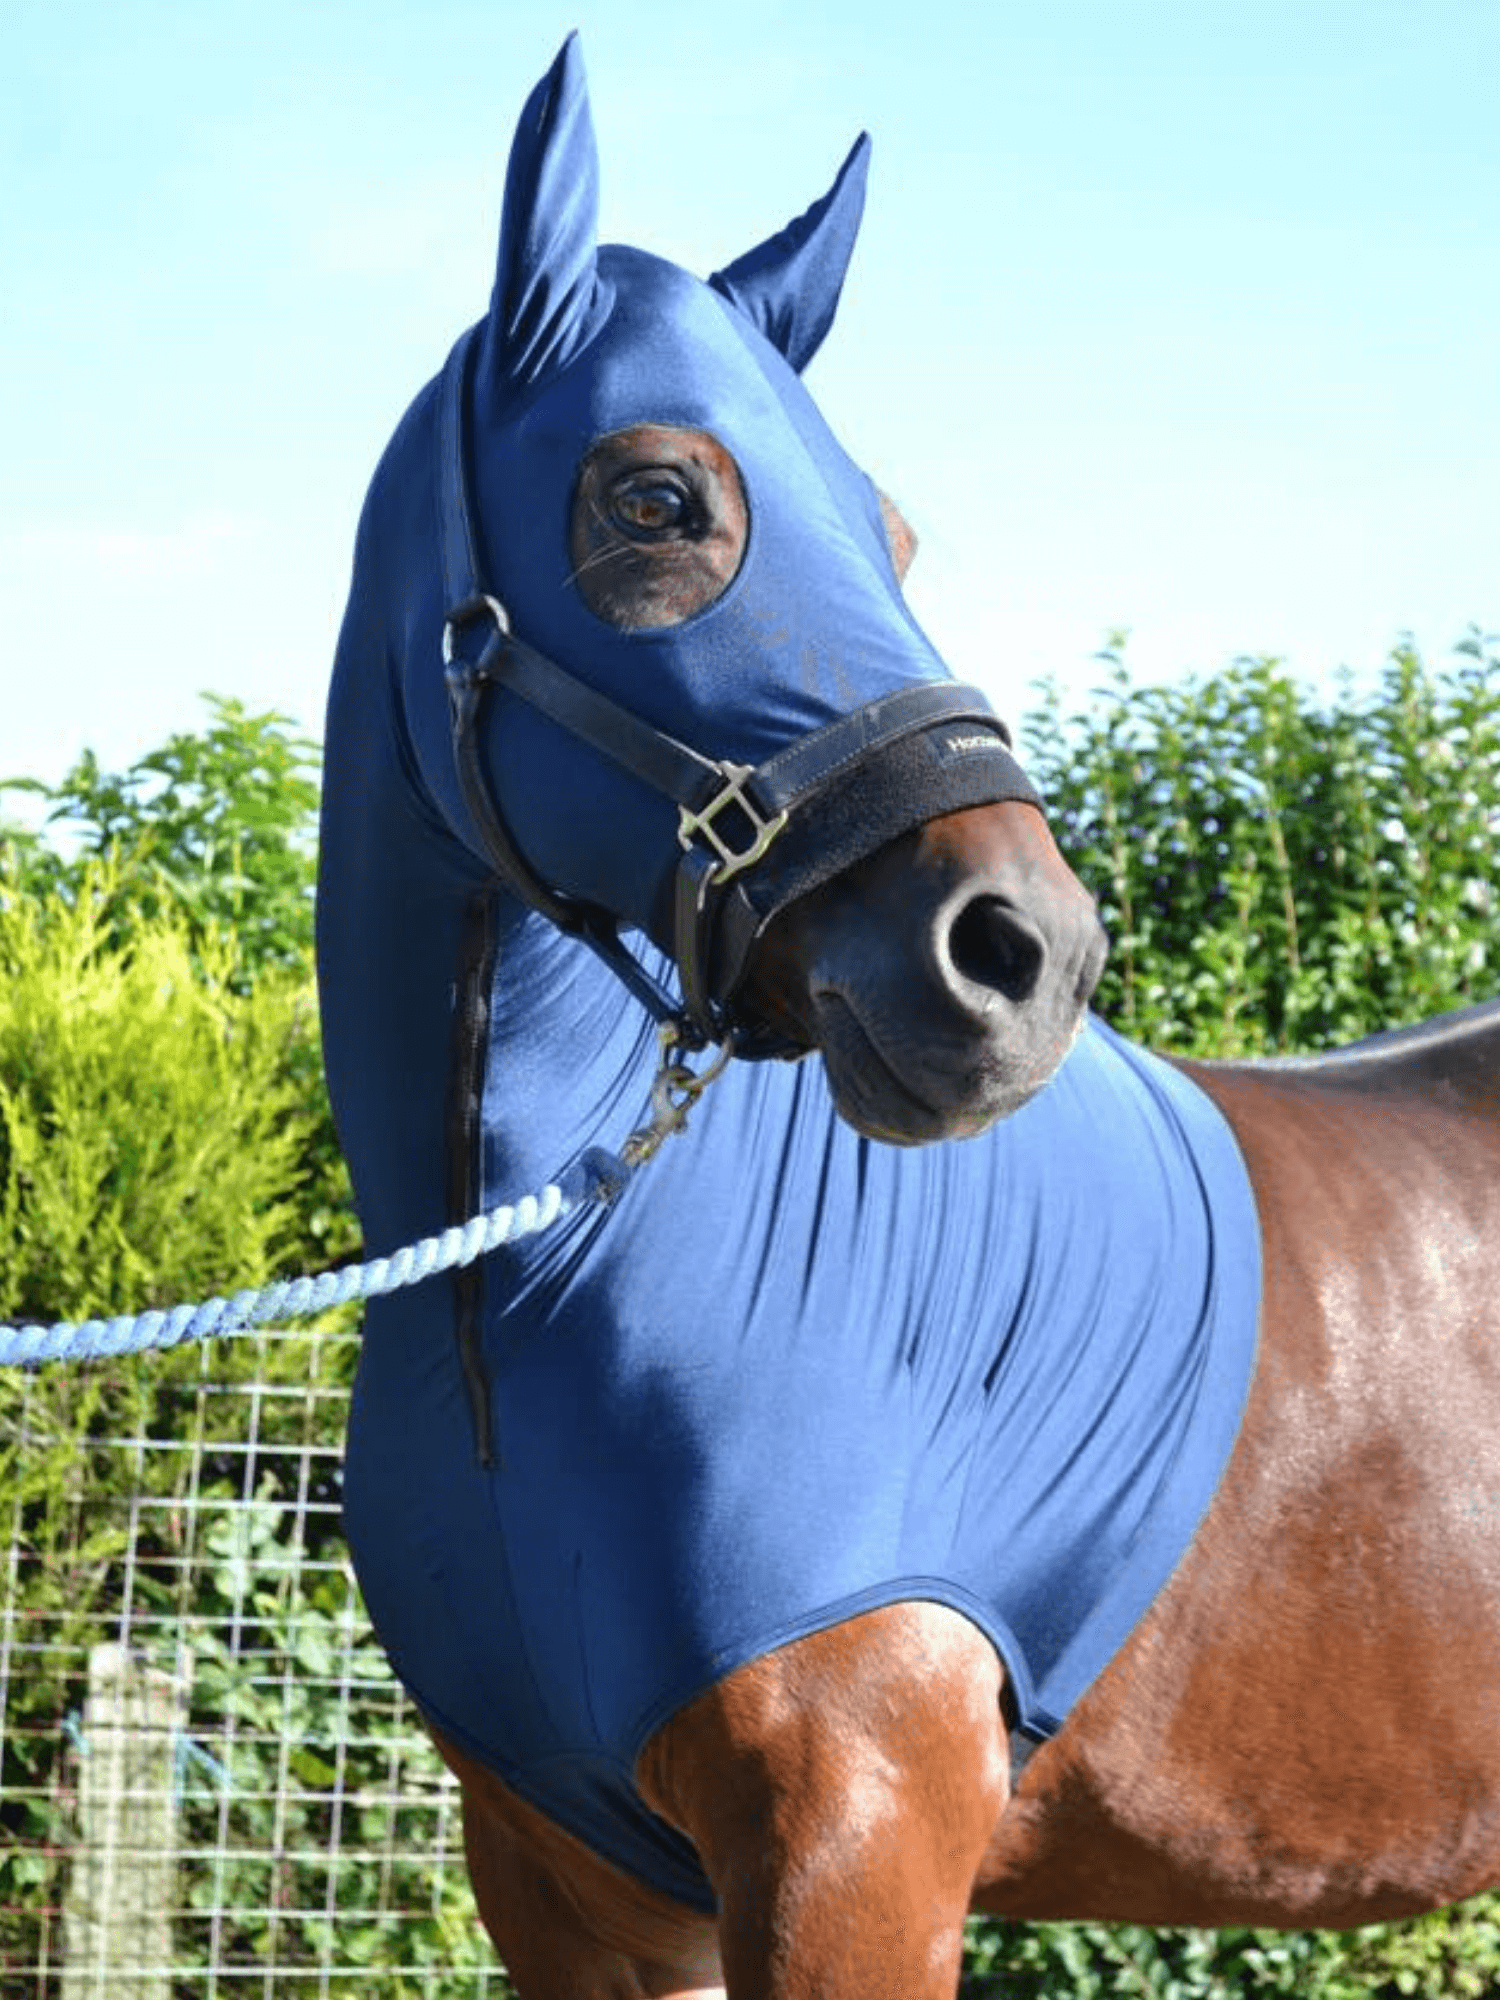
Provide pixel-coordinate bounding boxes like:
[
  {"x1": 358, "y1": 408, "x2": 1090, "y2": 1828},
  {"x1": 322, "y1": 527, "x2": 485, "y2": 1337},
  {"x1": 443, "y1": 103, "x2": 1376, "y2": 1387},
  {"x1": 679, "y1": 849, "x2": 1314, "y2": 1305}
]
[{"x1": 0, "y1": 1326, "x2": 508, "y2": 2000}]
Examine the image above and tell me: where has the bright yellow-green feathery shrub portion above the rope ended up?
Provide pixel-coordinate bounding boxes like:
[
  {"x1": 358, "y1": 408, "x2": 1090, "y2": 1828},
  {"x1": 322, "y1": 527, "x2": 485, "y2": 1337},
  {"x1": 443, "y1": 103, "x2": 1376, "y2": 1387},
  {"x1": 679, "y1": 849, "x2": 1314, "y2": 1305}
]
[{"x1": 0, "y1": 862, "x2": 314, "y2": 1320}]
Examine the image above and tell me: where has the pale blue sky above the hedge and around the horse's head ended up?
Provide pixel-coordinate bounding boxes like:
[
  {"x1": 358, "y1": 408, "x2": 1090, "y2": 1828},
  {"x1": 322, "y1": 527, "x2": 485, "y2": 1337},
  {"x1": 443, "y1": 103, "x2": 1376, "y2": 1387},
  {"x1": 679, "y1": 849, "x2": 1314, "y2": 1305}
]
[{"x1": 0, "y1": 0, "x2": 1500, "y2": 804}]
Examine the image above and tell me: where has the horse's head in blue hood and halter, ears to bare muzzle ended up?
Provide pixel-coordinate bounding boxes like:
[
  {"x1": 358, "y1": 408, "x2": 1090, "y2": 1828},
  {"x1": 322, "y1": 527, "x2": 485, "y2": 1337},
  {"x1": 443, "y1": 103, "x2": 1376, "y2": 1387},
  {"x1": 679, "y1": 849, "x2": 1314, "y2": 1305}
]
[{"x1": 440, "y1": 42, "x2": 1104, "y2": 1142}]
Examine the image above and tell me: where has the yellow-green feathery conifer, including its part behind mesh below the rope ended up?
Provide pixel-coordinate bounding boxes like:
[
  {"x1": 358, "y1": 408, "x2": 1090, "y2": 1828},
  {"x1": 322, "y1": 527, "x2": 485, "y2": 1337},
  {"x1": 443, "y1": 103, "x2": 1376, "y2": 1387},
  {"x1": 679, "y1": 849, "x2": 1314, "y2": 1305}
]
[{"x1": 0, "y1": 862, "x2": 334, "y2": 1856}]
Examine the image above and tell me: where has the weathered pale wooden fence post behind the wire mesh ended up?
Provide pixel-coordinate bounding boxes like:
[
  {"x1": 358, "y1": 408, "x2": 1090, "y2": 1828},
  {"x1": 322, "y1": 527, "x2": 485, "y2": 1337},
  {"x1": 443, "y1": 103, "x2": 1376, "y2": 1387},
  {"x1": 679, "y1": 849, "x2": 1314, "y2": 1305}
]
[{"x1": 62, "y1": 1642, "x2": 186, "y2": 2000}]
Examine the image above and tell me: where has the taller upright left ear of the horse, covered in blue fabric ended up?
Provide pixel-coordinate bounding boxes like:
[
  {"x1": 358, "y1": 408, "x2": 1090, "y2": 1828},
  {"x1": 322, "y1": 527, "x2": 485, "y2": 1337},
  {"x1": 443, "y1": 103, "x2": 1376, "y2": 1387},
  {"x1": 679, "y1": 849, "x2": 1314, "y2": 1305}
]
[{"x1": 484, "y1": 34, "x2": 608, "y2": 390}]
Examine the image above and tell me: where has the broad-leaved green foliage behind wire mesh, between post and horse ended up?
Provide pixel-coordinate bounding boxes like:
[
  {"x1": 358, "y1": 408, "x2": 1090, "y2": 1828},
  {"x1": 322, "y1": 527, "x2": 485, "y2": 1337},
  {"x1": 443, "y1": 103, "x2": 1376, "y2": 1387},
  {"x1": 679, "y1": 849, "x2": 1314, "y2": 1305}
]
[{"x1": 162, "y1": 1494, "x2": 500, "y2": 1996}]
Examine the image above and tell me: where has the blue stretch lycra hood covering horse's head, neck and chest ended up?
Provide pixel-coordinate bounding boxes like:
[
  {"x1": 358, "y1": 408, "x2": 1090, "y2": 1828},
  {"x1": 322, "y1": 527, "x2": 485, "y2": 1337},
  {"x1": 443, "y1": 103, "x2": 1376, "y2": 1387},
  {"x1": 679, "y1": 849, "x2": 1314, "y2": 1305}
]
[{"x1": 318, "y1": 31, "x2": 1260, "y2": 1910}]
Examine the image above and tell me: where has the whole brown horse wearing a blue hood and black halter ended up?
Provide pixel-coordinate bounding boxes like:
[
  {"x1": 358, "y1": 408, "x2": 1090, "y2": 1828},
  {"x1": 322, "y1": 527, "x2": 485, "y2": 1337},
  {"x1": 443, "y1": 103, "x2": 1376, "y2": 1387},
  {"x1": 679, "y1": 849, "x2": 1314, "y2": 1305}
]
[{"x1": 318, "y1": 40, "x2": 1500, "y2": 2000}]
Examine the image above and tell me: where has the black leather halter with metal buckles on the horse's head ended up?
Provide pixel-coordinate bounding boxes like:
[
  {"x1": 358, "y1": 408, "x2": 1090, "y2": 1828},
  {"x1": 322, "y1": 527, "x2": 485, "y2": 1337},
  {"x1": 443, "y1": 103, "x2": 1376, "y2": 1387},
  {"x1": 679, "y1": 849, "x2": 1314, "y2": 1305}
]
[{"x1": 438, "y1": 326, "x2": 1040, "y2": 1056}]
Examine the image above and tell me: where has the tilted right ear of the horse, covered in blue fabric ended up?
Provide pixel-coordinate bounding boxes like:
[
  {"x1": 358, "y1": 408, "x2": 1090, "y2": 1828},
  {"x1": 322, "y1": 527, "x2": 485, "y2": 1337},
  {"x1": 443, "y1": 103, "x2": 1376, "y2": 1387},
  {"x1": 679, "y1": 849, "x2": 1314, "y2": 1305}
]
[{"x1": 708, "y1": 132, "x2": 870, "y2": 374}]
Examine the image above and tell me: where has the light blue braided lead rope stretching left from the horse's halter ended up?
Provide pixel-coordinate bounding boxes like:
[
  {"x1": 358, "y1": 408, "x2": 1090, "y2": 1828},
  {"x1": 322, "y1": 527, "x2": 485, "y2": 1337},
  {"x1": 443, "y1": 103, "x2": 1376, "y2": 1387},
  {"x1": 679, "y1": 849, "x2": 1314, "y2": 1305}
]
[{"x1": 0, "y1": 1148, "x2": 630, "y2": 1368}]
